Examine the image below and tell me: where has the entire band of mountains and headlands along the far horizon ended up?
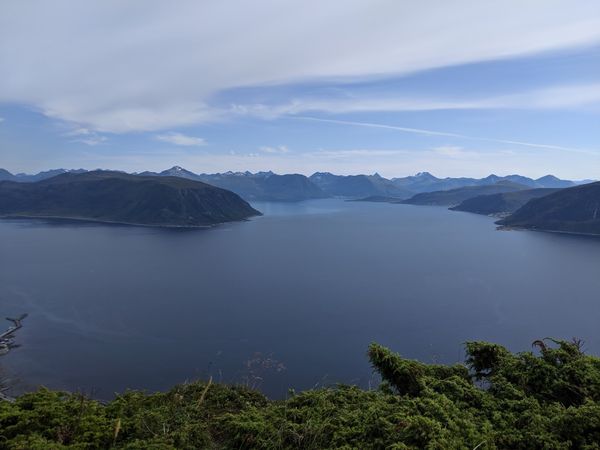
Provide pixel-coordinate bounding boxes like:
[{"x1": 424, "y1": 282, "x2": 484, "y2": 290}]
[{"x1": 0, "y1": 166, "x2": 600, "y2": 234}]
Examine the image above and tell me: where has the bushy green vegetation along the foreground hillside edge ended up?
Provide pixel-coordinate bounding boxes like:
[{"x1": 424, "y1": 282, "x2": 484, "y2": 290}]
[{"x1": 0, "y1": 340, "x2": 600, "y2": 450}]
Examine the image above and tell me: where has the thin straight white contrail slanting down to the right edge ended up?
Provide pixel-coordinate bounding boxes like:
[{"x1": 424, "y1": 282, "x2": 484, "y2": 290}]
[{"x1": 288, "y1": 116, "x2": 600, "y2": 156}]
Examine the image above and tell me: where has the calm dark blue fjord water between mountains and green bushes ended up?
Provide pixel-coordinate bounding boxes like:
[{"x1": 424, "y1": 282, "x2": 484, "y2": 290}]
[{"x1": 0, "y1": 200, "x2": 600, "y2": 398}]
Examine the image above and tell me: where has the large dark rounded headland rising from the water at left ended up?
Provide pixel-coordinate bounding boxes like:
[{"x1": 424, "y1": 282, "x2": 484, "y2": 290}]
[{"x1": 0, "y1": 171, "x2": 260, "y2": 227}]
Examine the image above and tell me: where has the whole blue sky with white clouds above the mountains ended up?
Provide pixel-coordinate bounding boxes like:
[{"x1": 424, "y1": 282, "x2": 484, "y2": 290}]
[{"x1": 0, "y1": 0, "x2": 600, "y2": 179}]
